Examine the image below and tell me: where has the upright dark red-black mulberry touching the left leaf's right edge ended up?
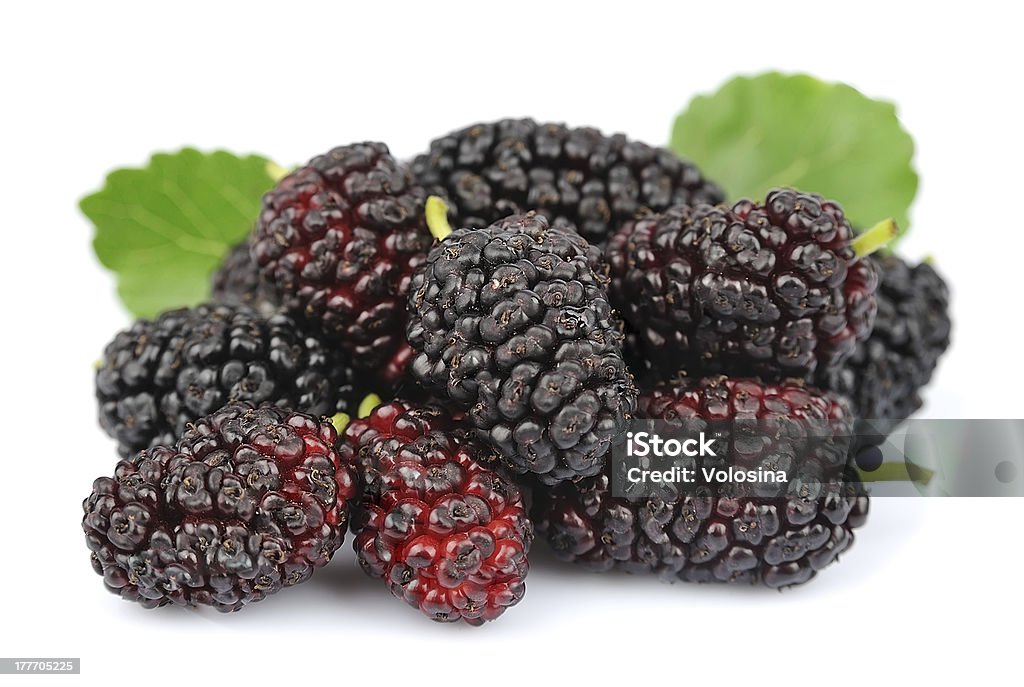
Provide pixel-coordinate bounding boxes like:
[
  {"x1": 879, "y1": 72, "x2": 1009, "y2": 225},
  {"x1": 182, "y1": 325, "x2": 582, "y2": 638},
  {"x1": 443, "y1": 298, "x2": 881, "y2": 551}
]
[{"x1": 252, "y1": 143, "x2": 432, "y2": 372}]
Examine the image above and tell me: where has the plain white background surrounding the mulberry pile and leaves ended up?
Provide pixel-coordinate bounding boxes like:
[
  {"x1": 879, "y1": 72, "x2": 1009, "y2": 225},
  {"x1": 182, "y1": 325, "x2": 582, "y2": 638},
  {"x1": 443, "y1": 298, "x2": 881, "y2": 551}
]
[{"x1": 0, "y1": 0, "x2": 1024, "y2": 685}]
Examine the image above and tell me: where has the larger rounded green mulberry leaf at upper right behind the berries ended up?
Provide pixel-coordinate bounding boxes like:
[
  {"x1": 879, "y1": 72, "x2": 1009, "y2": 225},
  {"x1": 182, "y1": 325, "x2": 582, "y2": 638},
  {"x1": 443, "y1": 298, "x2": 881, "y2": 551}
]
[{"x1": 671, "y1": 72, "x2": 918, "y2": 239}]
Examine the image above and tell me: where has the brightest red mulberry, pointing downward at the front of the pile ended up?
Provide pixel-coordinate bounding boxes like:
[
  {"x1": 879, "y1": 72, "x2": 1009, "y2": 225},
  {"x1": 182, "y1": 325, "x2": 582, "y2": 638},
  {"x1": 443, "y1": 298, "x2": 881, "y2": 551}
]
[{"x1": 340, "y1": 401, "x2": 534, "y2": 625}]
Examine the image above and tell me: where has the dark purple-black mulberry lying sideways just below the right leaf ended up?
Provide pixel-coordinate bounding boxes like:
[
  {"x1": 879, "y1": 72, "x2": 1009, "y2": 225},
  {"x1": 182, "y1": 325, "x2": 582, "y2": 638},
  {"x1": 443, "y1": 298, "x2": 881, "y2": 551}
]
[{"x1": 606, "y1": 190, "x2": 878, "y2": 380}]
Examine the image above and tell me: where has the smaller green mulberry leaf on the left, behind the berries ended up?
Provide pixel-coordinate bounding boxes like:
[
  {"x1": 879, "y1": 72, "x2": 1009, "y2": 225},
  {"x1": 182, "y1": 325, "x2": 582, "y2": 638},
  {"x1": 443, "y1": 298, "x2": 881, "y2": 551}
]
[{"x1": 79, "y1": 148, "x2": 275, "y2": 317}]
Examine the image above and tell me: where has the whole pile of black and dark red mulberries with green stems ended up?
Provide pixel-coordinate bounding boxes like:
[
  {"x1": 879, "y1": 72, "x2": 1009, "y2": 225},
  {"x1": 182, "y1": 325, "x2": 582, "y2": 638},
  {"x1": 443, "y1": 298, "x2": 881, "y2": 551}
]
[{"x1": 82, "y1": 120, "x2": 951, "y2": 625}]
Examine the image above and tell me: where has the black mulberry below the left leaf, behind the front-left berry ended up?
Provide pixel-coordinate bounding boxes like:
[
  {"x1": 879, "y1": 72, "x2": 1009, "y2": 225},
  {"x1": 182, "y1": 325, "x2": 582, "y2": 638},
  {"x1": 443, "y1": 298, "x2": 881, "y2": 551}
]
[{"x1": 96, "y1": 305, "x2": 357, "y2": 456}]
